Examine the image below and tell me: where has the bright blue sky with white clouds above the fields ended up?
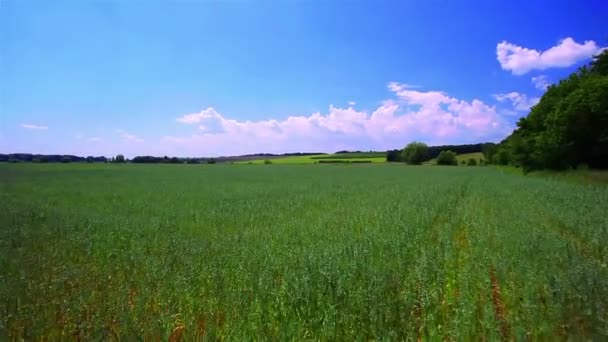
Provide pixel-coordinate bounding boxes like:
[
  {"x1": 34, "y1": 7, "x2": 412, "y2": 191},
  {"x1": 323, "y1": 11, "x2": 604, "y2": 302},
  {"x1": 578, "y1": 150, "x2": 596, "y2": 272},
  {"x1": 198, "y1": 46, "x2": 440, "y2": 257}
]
[{"x1": 0, "y1": 0, "x2": 608, "y2": 156}]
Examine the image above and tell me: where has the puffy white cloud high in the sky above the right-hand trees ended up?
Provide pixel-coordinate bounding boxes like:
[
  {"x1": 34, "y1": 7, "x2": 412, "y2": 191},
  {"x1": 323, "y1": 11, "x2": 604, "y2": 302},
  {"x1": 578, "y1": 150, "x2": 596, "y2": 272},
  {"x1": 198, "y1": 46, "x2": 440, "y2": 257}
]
[{"x1": 496, "y1": 37, "x2": 602, "y2": 75}]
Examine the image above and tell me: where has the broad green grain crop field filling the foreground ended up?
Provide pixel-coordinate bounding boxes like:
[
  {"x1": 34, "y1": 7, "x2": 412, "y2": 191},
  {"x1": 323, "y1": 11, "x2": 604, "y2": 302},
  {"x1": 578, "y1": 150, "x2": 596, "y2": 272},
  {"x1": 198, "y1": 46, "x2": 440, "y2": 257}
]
[{"x1": 0, "y1": 164, "x2": 608, "y2": 341}]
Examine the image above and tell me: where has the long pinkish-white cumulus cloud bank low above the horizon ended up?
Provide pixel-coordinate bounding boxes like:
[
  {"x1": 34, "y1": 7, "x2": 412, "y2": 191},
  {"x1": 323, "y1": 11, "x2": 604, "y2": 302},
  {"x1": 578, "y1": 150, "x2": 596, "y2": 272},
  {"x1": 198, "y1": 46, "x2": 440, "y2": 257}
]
[{"x1": 167, "y1": 82, "x2": 512, "y2": 155}]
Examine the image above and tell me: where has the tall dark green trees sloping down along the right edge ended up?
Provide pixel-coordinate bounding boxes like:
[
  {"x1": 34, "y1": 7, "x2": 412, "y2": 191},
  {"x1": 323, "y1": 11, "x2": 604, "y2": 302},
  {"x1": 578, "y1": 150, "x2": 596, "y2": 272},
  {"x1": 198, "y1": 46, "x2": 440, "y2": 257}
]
[{"x1": 485, "y1": 50, "x2": 608, "y2": 172}]
